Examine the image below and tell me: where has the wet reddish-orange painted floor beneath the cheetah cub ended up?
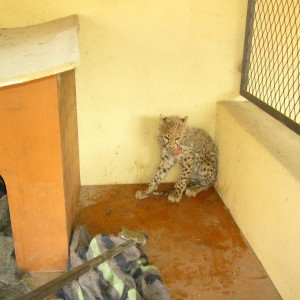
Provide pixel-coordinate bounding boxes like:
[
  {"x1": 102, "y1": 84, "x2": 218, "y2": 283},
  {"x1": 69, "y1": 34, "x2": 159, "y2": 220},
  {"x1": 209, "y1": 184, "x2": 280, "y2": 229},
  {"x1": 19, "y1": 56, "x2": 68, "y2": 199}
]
[{"x1": 77, "y1": 184, "x2": 281, "y2": 300}]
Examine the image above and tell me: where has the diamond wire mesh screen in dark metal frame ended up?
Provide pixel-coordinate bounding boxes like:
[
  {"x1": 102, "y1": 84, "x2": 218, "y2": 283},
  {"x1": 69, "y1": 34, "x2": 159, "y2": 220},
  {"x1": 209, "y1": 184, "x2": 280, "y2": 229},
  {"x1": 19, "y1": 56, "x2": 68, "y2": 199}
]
[{"x1": 241, "y1": 0, "x2": 300, "y2": 134}]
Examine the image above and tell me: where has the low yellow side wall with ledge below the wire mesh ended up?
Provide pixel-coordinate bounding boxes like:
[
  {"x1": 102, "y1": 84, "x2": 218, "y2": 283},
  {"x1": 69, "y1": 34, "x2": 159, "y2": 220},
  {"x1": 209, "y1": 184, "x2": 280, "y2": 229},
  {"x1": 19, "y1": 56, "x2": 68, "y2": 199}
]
[{"x1": 216, "y1": 102, "x2": 300, "y2": 300}]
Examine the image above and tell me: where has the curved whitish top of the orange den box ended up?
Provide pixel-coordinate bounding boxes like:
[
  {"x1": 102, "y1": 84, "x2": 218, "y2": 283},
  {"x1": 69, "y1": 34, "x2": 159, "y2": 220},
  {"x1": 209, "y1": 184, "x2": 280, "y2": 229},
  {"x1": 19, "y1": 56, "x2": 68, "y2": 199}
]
[{"x1": 0, "y1": 15, "x2": 79, "y2": 87}]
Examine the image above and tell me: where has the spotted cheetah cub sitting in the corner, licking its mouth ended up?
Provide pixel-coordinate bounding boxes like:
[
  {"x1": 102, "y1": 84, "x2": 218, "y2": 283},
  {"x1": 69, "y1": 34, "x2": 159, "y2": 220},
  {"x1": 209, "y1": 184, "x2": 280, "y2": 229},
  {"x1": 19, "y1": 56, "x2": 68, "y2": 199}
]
[{"x1": 135, "y1": 116, "x2": 218, "y2": 202}]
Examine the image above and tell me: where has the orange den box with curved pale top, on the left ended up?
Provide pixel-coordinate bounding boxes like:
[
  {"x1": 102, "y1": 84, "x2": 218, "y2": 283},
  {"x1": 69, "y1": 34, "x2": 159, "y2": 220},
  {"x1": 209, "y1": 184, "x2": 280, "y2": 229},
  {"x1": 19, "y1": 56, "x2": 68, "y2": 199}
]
[{"x1": 0, "y1": 16, "x2": 80, "y2": 271}]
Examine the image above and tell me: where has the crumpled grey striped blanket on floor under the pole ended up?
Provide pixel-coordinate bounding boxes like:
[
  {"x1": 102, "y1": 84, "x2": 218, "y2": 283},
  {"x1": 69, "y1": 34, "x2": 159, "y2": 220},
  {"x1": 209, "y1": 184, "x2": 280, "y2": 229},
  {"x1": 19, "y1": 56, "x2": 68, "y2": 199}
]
[{"x1": 56, "y1": 226, "x2": 171, "y2": 300}]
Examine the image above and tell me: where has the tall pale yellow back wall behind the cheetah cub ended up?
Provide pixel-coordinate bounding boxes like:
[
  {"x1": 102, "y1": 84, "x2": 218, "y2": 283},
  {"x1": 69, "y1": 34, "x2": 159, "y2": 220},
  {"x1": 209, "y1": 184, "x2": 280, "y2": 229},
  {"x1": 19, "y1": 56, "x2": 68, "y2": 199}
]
[{"x1": 0, "y1": 0, "x2": 246, "y2": 184}]
